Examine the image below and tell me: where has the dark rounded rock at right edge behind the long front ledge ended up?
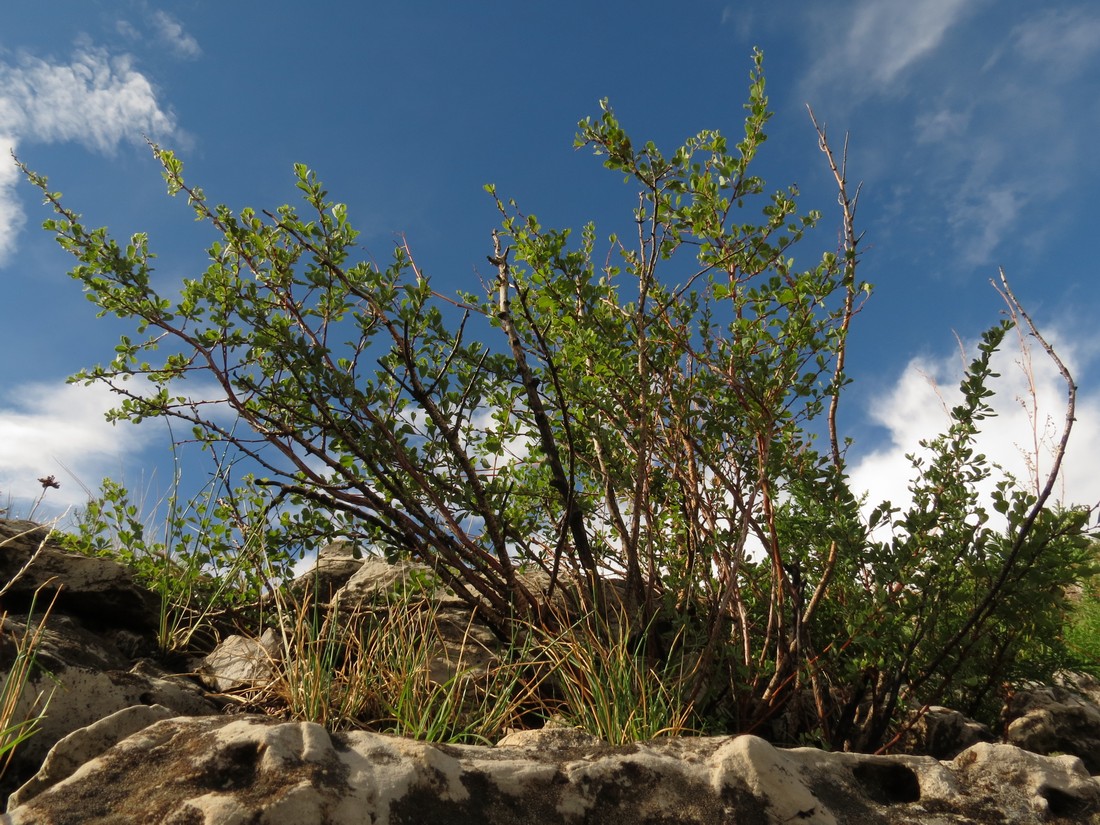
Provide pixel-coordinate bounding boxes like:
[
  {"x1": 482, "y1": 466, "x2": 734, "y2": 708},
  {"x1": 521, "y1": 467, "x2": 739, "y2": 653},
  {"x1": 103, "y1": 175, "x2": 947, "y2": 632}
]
[{"x1": 1002, "y1": 674, "x2": 1100, "y2": 773}]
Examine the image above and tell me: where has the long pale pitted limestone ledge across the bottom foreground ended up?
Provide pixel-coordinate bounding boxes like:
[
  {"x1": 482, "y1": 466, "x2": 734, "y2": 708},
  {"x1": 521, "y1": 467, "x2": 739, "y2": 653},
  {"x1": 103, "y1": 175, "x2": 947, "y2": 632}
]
[{"x1": 2, "y1": 716, "x2": 1100, "y2": 825}]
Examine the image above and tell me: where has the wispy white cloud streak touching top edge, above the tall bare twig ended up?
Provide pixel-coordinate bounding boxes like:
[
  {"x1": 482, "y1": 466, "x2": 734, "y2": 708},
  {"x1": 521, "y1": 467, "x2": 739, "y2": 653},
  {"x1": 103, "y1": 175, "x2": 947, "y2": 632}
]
[{"x1": 809, "y1": 0, "x2": 972, "y2": 102}]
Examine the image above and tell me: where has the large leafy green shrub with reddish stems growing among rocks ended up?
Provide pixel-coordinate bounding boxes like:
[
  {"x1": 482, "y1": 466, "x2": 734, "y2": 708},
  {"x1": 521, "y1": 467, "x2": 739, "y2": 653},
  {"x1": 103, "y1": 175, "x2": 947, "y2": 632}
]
[{"x1": 21, "y1": 53, "x2": 1095, "y2": 749}]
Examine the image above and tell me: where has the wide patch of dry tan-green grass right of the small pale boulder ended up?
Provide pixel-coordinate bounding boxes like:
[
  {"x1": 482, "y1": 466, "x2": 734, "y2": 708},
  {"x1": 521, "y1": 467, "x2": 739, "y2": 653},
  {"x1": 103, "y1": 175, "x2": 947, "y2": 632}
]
[{"x1": 237, "y1": 594, "x2": 554, "y2": 744}]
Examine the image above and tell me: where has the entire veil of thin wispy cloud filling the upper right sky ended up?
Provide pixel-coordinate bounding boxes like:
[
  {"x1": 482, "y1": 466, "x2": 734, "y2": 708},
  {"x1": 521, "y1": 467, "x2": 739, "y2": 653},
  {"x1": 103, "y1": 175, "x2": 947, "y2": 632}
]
[{"x1": 803, "y1": 0, "x2": 1100, "y2": 272}]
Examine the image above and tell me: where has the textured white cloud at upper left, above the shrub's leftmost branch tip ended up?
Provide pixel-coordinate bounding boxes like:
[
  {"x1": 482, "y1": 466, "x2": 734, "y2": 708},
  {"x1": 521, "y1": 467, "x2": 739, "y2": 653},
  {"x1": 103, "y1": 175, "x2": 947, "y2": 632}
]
[{"x1": 0, "y1": 48, "x2": 176, "y2": 264}]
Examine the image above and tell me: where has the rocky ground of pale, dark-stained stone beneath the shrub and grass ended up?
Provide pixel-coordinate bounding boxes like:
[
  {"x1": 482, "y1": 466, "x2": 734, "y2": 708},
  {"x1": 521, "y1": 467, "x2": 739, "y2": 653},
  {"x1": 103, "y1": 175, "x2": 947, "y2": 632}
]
[{"x1": 0, "y1": 521, "x2": 1100, "y2": 825}]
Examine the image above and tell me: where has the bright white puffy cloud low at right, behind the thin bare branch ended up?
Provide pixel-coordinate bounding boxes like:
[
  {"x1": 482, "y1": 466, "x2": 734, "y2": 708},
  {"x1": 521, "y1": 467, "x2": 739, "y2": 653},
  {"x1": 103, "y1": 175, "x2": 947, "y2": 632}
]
[{"x1": 851, "y1": 323, "x2": 1100, "y2": 530}]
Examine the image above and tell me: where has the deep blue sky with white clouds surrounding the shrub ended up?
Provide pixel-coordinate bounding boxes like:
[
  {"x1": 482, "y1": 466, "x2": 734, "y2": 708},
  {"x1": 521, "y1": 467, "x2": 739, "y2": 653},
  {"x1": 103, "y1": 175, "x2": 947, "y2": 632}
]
[{"x1": 0, "y1": 0, "x2": 1100, "y2": 523}]
